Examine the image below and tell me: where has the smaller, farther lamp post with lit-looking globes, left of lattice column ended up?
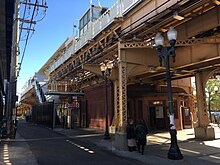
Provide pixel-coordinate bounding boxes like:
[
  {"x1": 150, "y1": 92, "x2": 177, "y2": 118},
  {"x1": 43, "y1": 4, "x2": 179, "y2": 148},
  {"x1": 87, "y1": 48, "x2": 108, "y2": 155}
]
[{"x1": 100, "y1": 61, "x2": 113, "y2": 139}]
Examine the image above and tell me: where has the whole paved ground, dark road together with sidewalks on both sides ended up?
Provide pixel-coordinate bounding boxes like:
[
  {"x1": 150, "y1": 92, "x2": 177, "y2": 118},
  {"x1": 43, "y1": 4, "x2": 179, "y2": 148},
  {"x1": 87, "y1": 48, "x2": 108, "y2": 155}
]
[{"x1": 0, "y1": 121, "x2": 220, "y2": 165}]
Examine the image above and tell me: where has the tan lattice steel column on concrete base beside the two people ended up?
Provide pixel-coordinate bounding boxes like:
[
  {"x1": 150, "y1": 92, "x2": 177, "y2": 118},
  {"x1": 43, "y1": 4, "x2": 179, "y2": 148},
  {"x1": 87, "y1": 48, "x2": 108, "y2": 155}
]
[{"x1": 115, "y1": 47, "x2": 127, "y2": 150}]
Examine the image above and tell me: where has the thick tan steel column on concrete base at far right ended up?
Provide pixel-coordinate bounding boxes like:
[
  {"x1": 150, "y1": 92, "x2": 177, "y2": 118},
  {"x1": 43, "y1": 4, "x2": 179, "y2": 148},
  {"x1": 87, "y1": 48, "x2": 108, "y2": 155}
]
[{"x1": 195, "y1": 72, "x2": 215, "y2": 140}]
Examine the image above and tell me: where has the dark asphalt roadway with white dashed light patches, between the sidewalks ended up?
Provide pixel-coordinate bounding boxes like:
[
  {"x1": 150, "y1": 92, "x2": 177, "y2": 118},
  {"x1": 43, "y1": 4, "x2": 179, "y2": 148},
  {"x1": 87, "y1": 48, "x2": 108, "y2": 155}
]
[{"x1": 18, "y1": 122, "x2": 141, "y2": 165}]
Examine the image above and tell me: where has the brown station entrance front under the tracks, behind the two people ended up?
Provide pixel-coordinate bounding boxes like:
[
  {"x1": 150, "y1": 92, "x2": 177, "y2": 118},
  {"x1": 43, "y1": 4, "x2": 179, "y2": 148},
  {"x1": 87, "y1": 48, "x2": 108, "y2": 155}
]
[{"x1": 128, "y1": 85, "x2": 194, "y2": 131}]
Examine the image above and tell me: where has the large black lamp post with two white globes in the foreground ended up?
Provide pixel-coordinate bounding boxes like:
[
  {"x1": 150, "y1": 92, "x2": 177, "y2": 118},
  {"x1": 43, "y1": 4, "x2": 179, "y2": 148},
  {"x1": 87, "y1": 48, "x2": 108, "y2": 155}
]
[{"x1": 155, "y1": 26, "x2": 183, "y2": 160}]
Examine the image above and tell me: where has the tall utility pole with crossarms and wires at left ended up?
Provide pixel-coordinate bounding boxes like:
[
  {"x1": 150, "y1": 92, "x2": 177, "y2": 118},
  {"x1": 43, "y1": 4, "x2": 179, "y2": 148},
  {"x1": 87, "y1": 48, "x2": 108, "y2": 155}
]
[{"x1": 6, "y1": 0, "x2": 48, "y2": 138}]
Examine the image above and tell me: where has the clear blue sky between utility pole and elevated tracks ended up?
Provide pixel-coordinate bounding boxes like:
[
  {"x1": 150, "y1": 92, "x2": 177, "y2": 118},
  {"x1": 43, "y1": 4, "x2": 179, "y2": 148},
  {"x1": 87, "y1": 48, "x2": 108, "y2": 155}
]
[{"x1": 17, "y1": 0, "x2": 116, "y2": 95}]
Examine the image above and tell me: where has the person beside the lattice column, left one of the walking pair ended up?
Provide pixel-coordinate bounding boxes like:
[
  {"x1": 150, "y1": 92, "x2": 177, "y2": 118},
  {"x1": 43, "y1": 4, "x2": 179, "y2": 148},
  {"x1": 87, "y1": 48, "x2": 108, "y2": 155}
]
[{"x1": 126, "y1": 119, "x2": 136, "y2": 152}]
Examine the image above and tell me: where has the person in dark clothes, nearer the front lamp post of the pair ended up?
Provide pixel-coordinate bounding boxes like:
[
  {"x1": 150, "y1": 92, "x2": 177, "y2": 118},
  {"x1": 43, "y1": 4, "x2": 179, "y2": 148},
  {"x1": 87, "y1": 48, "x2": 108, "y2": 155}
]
[{"x1": 135, "y1": 119, "x2": 148, "y2": 155}]
